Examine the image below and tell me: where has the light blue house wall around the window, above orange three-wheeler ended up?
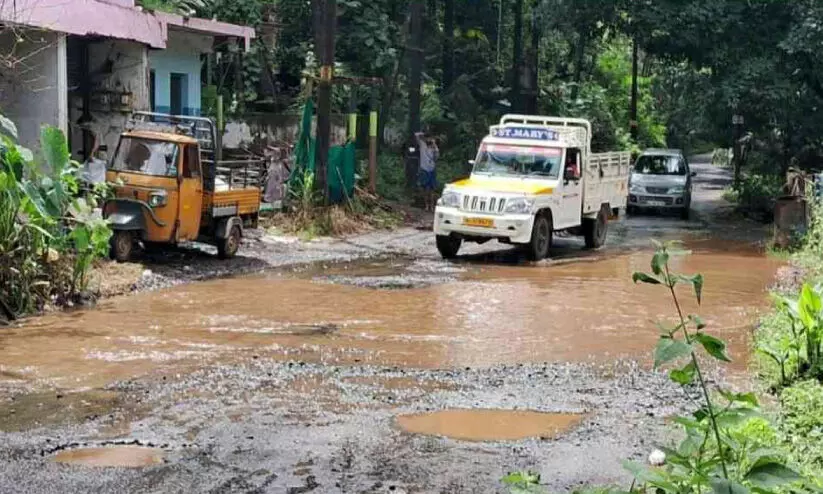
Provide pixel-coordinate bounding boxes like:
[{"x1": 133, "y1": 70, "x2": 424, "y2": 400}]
[{"x1": 149, "y1": 31, "x2": 211, "y2": 115}]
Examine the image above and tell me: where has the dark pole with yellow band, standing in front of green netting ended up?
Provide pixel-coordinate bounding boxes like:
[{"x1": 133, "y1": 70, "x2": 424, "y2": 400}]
[{"x1": 315, "y1": 0, "x2": 337, "y2": 201}]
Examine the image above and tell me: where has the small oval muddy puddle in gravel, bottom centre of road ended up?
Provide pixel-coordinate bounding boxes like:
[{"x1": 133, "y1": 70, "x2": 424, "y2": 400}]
[{"x1": 397, "y1": 409, "x2": 584, "y2": 441}]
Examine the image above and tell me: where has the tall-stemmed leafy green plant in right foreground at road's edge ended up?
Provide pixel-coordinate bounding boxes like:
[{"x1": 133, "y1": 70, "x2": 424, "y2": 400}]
[{"x1": 504, "y1": 242, "x2": 809, "y2": 494}]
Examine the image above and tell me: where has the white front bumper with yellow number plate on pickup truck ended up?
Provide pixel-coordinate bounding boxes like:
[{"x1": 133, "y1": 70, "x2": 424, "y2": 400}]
[{"x1": 434, "y1": 206, "x2": 534, "y2": 244}]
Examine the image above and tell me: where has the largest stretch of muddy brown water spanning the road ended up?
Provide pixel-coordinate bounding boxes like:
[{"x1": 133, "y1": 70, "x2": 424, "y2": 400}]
[{"x1": 0, "y1": 242, "x2": 780, "y2": 389}]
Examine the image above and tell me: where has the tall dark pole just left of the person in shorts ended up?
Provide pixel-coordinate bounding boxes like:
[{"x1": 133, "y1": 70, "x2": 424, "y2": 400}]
[{"x1": 406, "y1": 0, "x2": 426, "y2": 191}]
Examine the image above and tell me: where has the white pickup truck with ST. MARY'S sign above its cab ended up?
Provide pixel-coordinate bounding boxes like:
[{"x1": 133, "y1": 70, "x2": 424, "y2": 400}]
[{"x1": 434, "y1": 115, "x2": 631, "y2": 260}]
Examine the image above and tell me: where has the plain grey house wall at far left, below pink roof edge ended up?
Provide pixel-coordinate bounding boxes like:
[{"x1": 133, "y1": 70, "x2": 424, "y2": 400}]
[{"x1": 0, "y1": 29, "x2": 67, "y2": 150}]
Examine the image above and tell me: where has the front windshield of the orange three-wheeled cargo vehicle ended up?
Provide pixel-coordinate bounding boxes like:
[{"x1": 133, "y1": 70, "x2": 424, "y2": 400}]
[{"x1": 111, "y1": 137, "x2": 178, "y2": 177}]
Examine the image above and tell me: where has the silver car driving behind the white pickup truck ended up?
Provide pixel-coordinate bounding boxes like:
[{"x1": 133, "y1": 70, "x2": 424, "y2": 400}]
[{"x1": 626, "y1": 149, "x2": 695, "y2": 219}]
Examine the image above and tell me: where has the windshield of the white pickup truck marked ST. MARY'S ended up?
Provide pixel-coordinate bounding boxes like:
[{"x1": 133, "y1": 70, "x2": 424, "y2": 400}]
[{"x1": 474, "y1": 144, "x2": 563, "y2": 178}]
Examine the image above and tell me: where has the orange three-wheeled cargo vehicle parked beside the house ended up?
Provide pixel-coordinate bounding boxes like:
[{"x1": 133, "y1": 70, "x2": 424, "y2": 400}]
[{"x1": 103, "y1": 112, "x2": 262, "y2": 262}]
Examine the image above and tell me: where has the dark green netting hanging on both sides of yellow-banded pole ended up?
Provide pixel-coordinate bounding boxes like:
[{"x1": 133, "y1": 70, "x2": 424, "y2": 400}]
[{"x1": 289, "y1": 100, "x2": 357, "y2": 203}]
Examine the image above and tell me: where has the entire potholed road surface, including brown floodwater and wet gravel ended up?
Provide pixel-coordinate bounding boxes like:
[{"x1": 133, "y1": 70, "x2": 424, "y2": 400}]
[{"x1": 0, "y1": 156, "x2": 780, "y2": 494}]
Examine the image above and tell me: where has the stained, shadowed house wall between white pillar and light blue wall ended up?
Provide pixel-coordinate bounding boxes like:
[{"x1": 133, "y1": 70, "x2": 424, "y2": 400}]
[{"x1": 69, "y1": 38, "x2": 149, "y2": 159}]
